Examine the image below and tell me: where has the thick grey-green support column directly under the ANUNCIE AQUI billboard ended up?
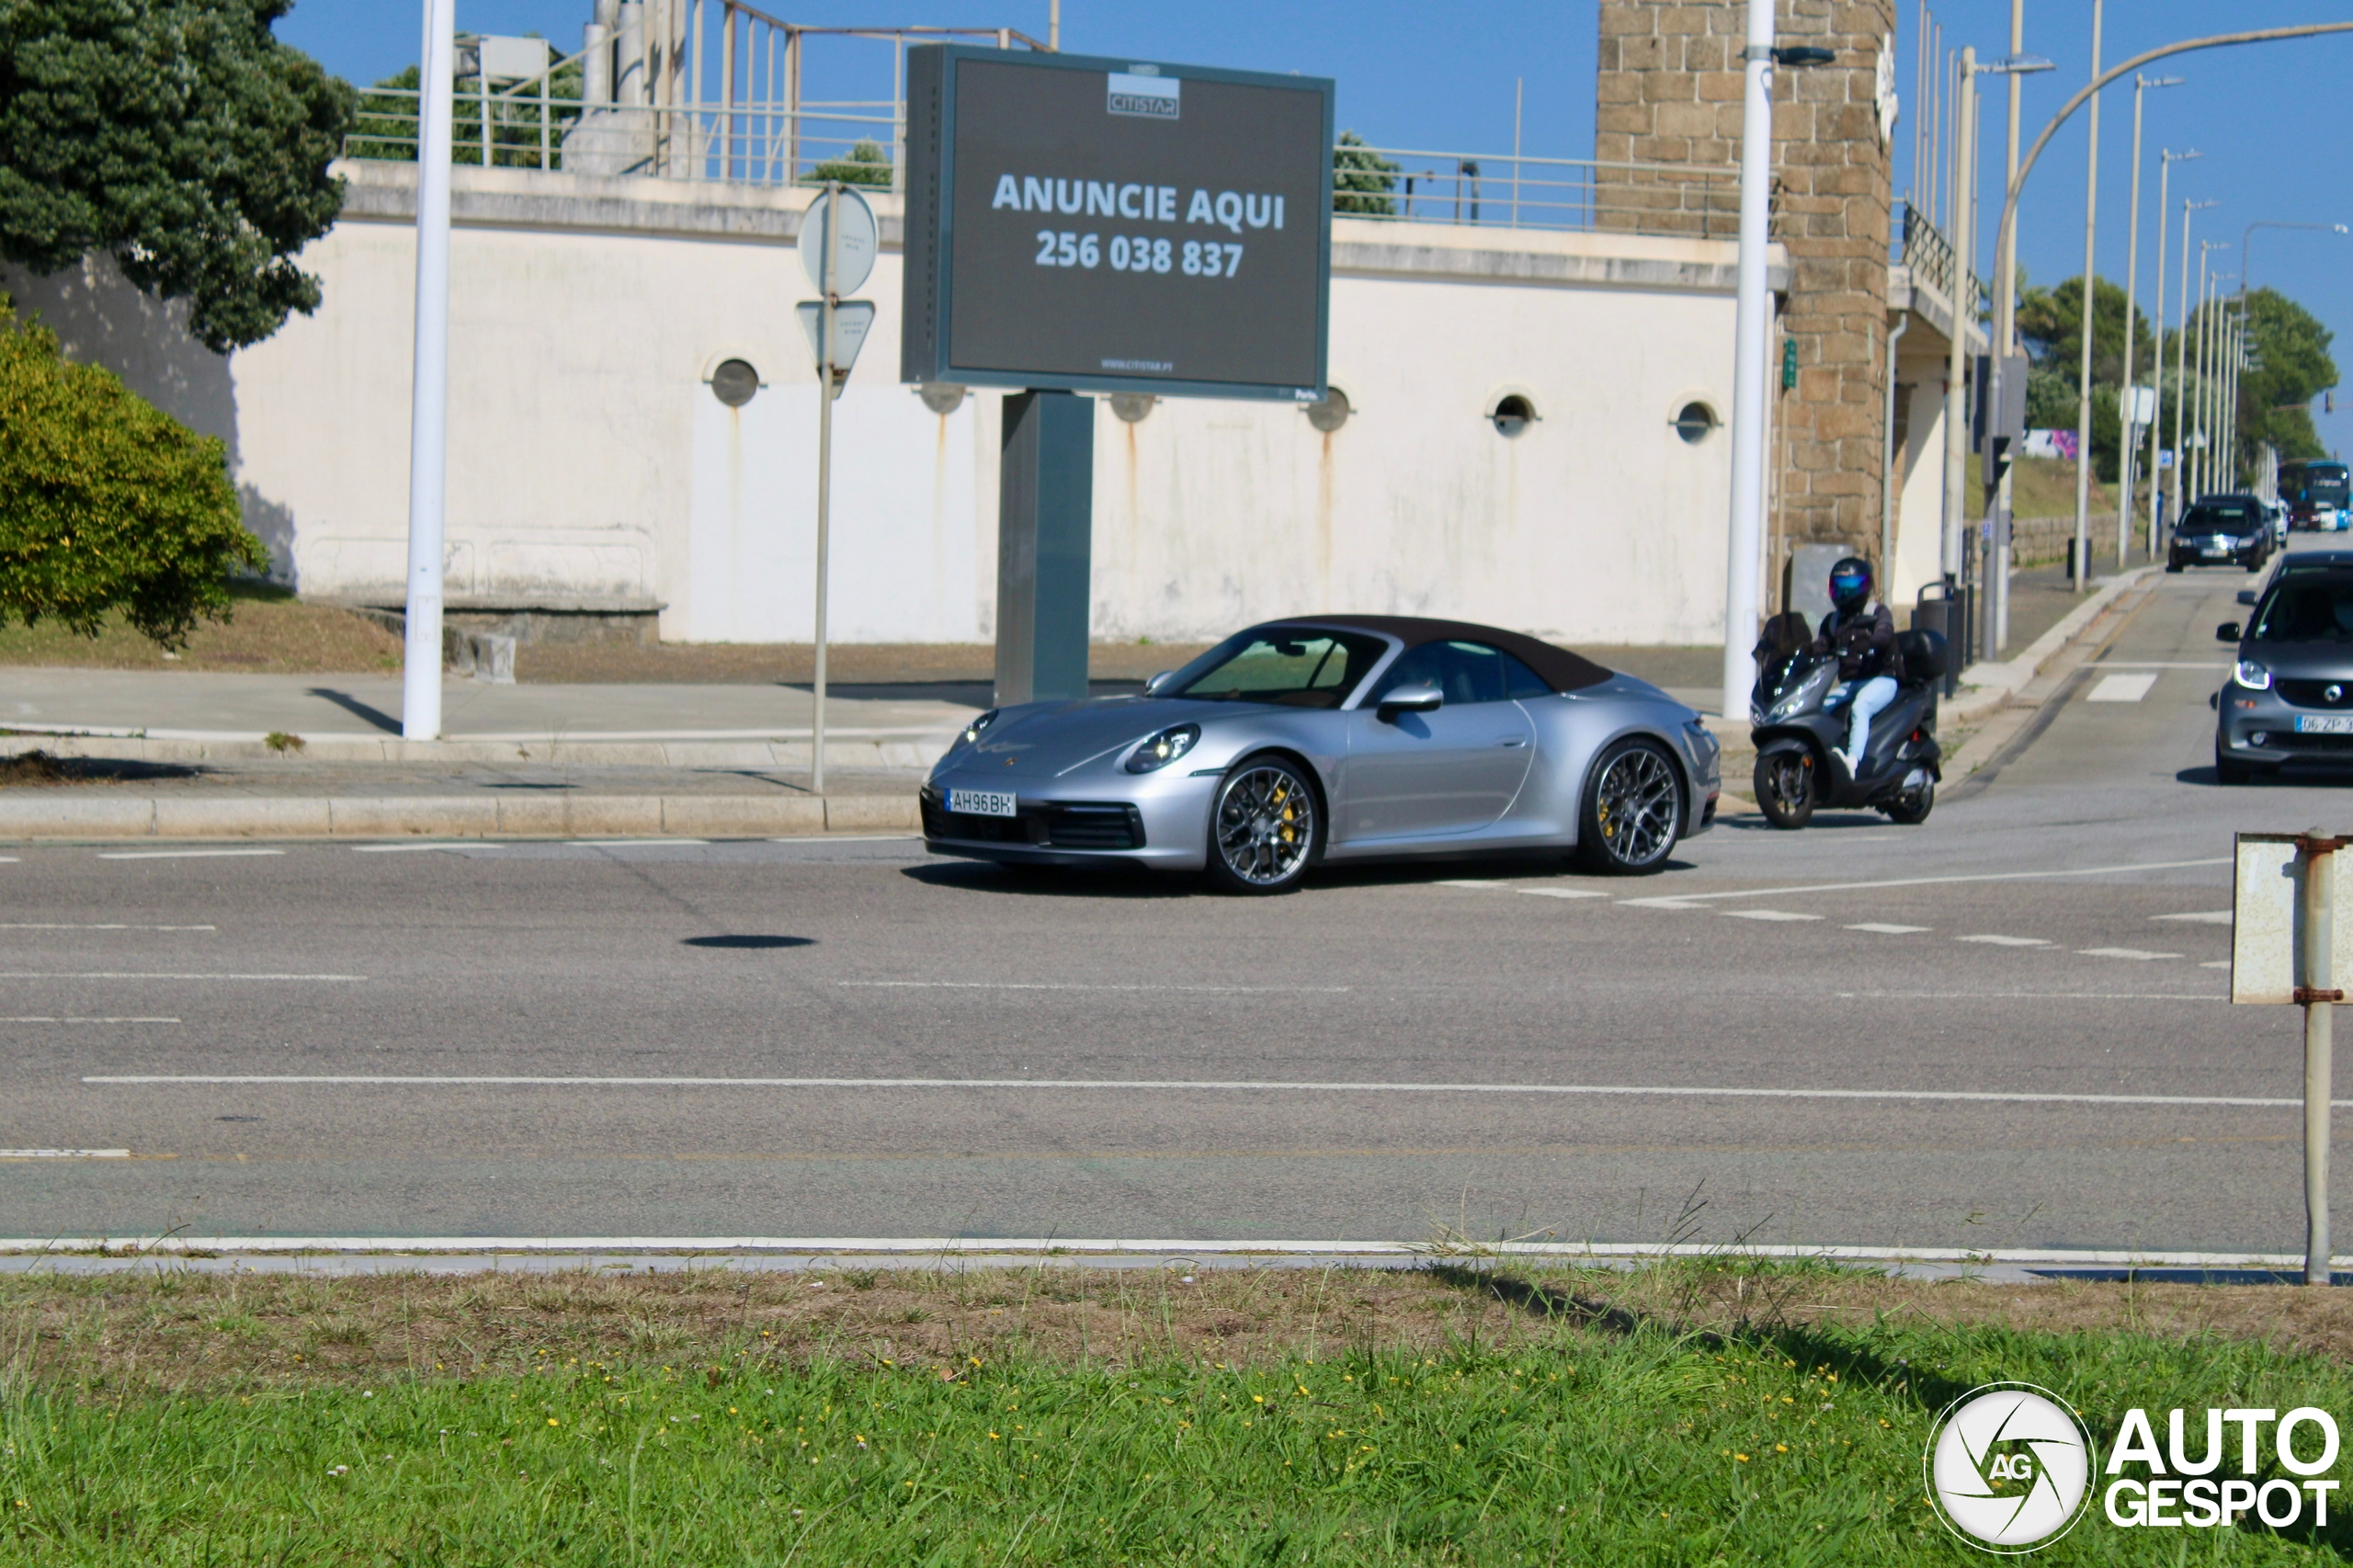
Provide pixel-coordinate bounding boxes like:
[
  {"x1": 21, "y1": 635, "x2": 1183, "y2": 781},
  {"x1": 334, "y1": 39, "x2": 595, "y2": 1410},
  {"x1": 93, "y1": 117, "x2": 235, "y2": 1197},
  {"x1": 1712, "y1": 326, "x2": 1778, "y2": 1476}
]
[{"x1": 995, "y1": 391, "x2": 1094, "y2": 706}]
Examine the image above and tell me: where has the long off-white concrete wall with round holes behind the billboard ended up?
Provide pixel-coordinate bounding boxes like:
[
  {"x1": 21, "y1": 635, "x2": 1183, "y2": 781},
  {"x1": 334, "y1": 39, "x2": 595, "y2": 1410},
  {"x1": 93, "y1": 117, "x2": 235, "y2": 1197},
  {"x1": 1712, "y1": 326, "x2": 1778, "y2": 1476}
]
[{"x1": 0, "y1": 165, "x2": 1769, "y2": 642}]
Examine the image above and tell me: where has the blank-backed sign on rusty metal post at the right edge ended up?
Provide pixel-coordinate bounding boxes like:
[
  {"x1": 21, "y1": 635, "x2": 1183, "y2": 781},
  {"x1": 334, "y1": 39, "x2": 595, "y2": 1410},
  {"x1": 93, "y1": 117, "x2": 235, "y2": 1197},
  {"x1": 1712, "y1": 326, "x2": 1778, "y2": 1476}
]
[{"x1": 2231, "y1": 829, "x2": 2353, "y2": 1286}]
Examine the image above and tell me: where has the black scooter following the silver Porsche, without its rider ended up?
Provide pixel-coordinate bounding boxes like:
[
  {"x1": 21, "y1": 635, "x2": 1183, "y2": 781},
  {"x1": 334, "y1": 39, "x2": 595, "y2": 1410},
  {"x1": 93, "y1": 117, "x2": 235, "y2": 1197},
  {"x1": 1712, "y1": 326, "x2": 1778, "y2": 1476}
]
[{"x1": 1748, "y1": 615, "x2": 1946, "y2": 829}]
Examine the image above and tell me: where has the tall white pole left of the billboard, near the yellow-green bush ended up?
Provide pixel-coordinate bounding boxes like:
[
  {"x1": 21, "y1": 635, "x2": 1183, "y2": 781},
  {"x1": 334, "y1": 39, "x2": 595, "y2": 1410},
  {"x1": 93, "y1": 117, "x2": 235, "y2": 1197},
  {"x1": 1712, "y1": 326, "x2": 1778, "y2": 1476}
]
[{"x1": 400, "y1": 0, "x2": 457, "y2": 739}]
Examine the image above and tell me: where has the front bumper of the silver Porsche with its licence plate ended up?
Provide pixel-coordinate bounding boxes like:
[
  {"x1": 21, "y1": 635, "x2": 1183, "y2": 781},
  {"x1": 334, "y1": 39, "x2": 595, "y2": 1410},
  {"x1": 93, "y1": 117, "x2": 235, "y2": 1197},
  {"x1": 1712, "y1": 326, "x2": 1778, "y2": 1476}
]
[{"x1": 920, "y1": 763, "x2": 1226, "y2": 871}]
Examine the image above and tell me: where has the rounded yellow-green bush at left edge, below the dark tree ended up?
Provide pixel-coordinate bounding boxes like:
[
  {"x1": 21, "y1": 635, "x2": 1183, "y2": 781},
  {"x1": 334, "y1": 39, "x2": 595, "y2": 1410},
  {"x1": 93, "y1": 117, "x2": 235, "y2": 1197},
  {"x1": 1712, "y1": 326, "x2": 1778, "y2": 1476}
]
[{"x1": 0, "y1": 294, "x2": 268, "y2": 647}]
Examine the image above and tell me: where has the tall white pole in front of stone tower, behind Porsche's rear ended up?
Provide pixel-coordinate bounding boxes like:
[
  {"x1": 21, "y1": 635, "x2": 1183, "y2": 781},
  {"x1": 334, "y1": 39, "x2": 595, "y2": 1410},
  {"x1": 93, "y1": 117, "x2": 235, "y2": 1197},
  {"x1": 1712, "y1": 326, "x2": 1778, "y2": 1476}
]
[{"x1": 1724, "y1": 0, "x2": 1774, "y2": 728}]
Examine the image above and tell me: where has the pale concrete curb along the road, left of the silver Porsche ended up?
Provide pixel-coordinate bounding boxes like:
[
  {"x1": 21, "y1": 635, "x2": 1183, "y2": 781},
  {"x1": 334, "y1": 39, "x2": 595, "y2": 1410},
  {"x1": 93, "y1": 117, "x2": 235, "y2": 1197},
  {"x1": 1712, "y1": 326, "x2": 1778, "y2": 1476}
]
[{"x1": 0, "y1": 789, "x2": 923, "y2": 838}]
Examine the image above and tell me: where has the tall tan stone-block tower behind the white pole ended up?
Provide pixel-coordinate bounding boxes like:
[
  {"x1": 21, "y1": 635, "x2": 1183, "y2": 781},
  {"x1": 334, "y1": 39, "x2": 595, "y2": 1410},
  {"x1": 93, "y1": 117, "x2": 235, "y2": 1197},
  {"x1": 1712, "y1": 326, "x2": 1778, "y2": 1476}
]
[{"x1": 1593, "y1": 0, "x2": 1894, "y2": 579}]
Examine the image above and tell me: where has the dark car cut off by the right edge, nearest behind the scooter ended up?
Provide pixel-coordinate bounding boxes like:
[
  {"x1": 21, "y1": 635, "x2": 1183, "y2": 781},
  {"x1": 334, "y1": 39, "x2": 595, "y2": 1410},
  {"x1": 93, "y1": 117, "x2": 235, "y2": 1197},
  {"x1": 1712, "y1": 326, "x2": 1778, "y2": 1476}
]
[{"x1": 2214, "y1": 551, "x2": 2353, "y2": 784}]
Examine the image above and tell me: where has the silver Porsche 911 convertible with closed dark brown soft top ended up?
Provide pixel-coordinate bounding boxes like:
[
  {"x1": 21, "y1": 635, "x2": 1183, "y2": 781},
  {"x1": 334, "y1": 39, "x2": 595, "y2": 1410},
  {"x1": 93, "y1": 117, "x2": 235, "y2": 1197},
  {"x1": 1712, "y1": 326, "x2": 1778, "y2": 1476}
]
[{"x1": 923, "y1": 615, "x2": 1718, "y2": 892}]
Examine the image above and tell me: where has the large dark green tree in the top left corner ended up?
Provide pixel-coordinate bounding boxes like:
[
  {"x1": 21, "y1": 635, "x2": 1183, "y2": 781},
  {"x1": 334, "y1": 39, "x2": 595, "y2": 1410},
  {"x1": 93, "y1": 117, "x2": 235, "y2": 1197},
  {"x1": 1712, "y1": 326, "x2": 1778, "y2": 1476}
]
[{"x1": 0, "y1": 0, "x2": 350, "y2": 353}]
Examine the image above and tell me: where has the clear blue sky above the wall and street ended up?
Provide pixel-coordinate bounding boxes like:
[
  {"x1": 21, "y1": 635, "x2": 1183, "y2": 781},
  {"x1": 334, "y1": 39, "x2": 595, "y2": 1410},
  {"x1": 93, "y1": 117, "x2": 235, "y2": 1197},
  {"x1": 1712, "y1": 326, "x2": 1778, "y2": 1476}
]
[{"x1": 278, "y1": 0, "x2": 2353, "y2": 449}]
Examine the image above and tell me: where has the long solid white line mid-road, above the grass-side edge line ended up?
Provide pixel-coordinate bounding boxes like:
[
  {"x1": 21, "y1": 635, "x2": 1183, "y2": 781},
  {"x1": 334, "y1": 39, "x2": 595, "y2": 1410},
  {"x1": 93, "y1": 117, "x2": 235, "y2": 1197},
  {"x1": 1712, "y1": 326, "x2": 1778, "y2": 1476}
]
[{"x1": 83, "y1": 1074, "x2": 2315, "y2": 1108}]
